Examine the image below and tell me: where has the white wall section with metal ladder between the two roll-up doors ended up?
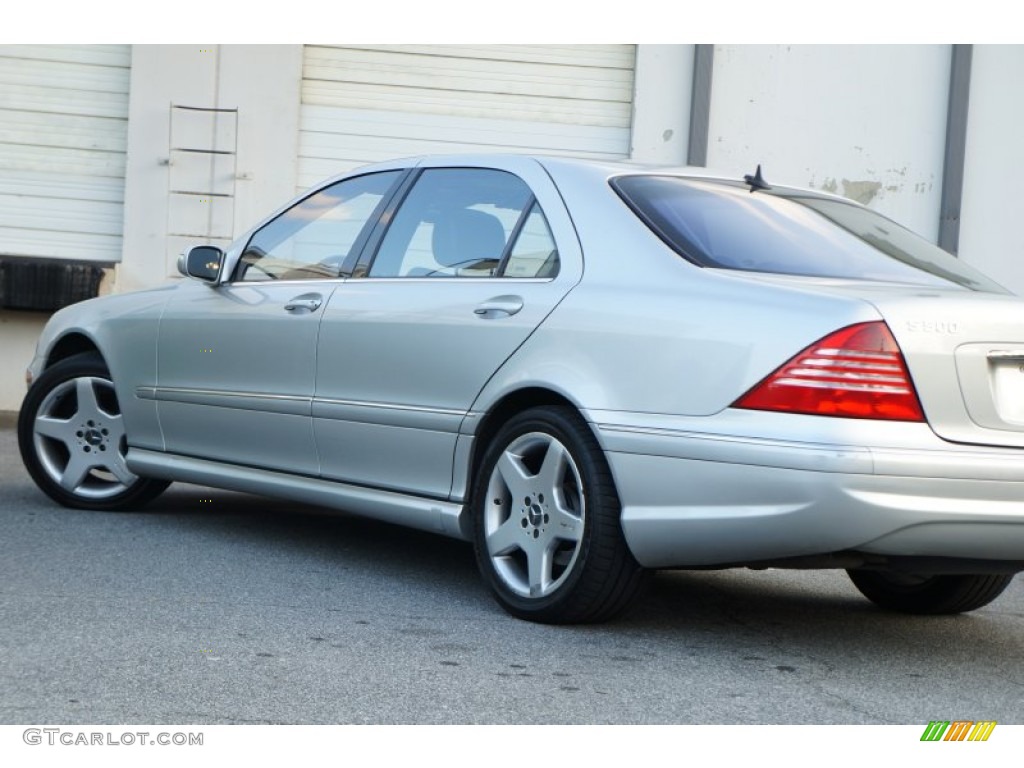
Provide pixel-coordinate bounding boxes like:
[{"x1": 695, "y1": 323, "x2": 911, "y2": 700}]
[{"x1": 116, "y1": 45, "x2": 302, "y2": 291}]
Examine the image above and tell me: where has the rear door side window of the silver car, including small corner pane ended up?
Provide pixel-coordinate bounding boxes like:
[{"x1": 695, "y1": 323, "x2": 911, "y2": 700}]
[{"x1": 370, "y1": 168, "x2": 557, "y2": 278}]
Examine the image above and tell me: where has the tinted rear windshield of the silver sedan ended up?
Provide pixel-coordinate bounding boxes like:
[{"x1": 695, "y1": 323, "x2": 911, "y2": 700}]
[{"x1": 611, "y1": 175, "x2": 1007, "y2": 293}]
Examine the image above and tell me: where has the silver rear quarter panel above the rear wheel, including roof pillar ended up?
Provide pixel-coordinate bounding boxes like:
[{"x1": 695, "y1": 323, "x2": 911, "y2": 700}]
[{"x1": 473, "y1": 162, "x2": 880, "y2": 416}]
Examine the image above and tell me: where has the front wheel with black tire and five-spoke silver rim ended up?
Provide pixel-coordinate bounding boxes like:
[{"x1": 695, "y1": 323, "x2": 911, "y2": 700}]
[{"x1": 17, "y1": 353, "x2": 170, "y2": 511}]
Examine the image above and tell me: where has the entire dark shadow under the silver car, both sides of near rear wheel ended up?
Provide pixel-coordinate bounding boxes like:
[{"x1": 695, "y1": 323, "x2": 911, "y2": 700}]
[{"x1": 145, "y1": 484, "x2": 1019, "y2": 647}]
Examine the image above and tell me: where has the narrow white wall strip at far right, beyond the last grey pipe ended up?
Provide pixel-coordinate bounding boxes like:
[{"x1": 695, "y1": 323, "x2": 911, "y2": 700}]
[{"x1": 959, "y1": 45, "x2": 1024, "y2": 294}]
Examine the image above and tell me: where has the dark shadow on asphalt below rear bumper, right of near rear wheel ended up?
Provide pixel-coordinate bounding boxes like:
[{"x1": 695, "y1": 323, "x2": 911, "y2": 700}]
[{"x1": 617, "y1": 568, "x2": 1024, "y2": 675}]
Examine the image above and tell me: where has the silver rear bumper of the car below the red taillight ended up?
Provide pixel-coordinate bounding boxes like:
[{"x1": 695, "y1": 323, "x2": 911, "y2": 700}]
[{"x1": 595, "y1": 417, "x2": 1024, "y2": 570}]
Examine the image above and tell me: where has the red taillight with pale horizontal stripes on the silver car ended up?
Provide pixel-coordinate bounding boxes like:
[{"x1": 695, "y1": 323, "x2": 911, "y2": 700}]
[{"x1": 733, "y1": 322, "x2": 925, "y2": 421}]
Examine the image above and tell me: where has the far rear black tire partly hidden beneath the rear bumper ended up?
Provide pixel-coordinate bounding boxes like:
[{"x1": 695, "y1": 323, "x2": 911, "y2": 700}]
[{"x1": 847, "y1": 570, "x2": 1014, "y2": 615}]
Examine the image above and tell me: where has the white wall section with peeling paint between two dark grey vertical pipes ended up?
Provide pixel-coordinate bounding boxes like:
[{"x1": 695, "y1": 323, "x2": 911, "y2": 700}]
[{"x1": 708, "y1": 45, "x2": 950, "y2": 242}]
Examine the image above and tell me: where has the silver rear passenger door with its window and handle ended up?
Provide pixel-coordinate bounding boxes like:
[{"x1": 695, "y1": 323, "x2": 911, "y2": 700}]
[{"x1": 313, "y1": 160, "x2": 582, "y2": 498}]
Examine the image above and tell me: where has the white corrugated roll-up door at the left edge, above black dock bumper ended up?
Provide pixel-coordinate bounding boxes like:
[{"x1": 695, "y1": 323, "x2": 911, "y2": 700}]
[{"x1": 0, "y1": 45, "x2": 131, "y2": 261}]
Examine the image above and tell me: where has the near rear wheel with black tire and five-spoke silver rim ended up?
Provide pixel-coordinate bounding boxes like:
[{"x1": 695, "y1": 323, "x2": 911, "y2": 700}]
[{"x1": 471, "y1": 406, "x2": 647, "y2": 624}]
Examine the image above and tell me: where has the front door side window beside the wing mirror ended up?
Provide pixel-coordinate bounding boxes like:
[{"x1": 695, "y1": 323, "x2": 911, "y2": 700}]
[{"x1": 234, "y1": 171, "x2": 401, "y2": 282}]
